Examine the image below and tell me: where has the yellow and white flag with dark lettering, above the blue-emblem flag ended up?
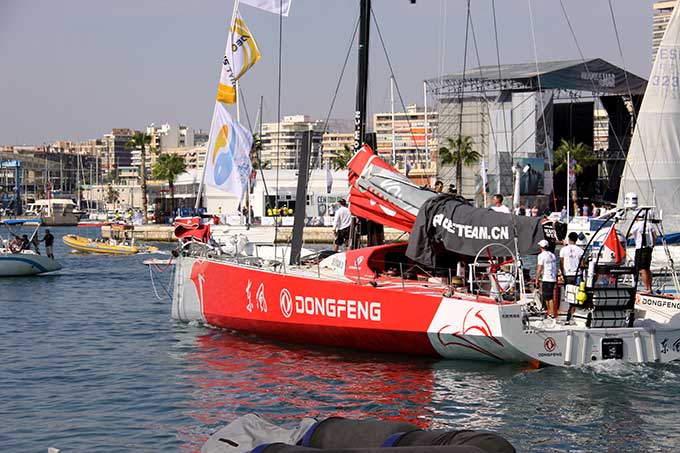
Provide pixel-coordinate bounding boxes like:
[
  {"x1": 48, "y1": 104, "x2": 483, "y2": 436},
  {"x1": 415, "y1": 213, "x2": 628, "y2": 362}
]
[{"x1": 217, "y1": 12, "x2": 262, "y2": 104}]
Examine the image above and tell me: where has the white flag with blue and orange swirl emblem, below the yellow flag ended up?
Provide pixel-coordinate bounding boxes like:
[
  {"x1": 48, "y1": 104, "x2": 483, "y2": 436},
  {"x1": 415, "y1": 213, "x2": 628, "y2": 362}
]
[{"x1": 203, "y1": 102, "x2": 253, "y2": 200}]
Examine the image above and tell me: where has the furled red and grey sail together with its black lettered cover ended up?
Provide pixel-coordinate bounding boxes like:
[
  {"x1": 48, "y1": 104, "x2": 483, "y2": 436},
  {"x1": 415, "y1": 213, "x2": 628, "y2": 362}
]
[{"x1": 348, "y1": 145, "x2": 564, "y2": 258}]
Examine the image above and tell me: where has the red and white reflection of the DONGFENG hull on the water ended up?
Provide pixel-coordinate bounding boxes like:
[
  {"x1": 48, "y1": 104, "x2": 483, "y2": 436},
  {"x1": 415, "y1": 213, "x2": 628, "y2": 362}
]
[{"x1": 174, "y1": 324, "x2": 532, "y2": 443}]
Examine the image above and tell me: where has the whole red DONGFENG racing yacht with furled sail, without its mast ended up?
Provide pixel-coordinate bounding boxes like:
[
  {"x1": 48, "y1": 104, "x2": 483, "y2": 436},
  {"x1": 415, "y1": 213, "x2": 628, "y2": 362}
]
[{"x1": 172, "y1": 146, "x2": 680, "y2": 366}]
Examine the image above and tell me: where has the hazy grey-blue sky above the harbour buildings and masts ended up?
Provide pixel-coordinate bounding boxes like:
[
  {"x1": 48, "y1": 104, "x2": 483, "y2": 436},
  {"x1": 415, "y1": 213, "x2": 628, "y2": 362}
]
[{"x1": 0, "y1": 0, "x2": 652, "y2": 145}]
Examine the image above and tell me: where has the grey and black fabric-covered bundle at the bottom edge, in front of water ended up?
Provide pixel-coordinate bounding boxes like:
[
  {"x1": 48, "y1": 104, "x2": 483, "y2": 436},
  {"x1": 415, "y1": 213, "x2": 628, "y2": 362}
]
[{"x1": 201, "y1": 414, "x2": 515, "y2": 453}]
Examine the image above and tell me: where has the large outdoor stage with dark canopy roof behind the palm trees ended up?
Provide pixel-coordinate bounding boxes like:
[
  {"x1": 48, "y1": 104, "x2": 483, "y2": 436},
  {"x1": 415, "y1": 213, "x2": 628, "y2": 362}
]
[{"x1": 426, "y1": 58, "x2": 647, "y2": 208}]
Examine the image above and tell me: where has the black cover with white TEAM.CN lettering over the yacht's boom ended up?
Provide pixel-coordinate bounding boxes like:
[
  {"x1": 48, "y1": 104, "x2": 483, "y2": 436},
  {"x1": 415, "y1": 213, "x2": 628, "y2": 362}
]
[{"x1": 406, "y1": 195, "x2": 552, "y2": 267}]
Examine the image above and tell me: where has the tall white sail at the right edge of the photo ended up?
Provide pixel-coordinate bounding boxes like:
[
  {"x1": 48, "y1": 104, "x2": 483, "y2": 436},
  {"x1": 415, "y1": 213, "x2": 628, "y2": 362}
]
[{"x1": 619, "y1": 4, "x2": 680, "y2": 233}]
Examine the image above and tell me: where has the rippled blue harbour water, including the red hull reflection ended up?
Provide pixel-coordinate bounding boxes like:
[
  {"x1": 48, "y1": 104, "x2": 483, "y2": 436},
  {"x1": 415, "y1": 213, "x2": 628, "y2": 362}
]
[{"x1": 0, "y1": 228, "x2": 680, "y2": 453}]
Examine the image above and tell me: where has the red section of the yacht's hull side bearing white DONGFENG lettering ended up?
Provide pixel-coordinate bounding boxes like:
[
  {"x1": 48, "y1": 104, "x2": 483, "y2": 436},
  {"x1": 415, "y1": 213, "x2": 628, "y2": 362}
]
[{"x1": 191, "y1": 261, "x2": 441, "y2": 328}]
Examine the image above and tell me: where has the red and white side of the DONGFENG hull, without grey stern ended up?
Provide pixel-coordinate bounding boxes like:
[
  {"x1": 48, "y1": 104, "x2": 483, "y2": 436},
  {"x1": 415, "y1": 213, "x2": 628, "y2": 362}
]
[{"x1": 173, "y1": 257, "x2": 531, "y2": 361}]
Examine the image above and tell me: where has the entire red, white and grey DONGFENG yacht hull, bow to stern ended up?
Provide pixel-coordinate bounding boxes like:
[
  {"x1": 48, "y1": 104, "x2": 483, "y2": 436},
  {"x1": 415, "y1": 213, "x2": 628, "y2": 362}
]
[{"x1": 172, "y1": 257, "x2": 680, "y2": 366}]
